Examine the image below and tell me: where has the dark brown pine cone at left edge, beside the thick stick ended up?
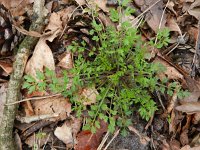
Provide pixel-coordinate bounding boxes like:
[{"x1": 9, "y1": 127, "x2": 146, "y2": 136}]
[{"x1": 0, "y1": 4, "x2": 20, "y2": 56}]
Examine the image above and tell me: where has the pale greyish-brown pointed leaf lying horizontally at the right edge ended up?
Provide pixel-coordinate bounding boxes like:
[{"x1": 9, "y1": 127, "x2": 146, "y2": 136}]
[{"x1": 176, "y1": 102, "x2": 200, "y2": 114}]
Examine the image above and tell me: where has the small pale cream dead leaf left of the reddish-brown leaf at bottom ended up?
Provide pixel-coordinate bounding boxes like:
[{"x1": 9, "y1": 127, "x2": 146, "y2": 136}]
[{"x1": 54, "y1": 122, "x2": 74, "y2": 144}]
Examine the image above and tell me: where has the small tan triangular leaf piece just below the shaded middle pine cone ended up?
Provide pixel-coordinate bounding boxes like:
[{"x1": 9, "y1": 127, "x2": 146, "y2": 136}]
[{"x1": 57, "y1": 52, "x2": 73, "y2": 69}]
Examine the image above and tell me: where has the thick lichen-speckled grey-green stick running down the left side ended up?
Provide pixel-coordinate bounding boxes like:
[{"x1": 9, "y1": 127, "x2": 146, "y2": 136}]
[{"x1": 0, "y1": 0, "x2": 46, "y2": 150}]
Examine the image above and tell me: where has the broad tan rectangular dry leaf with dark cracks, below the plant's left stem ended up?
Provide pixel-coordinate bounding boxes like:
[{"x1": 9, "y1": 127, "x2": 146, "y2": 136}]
[{"x1": 32, "y1": 96, "x2": 71, "y2": 121}]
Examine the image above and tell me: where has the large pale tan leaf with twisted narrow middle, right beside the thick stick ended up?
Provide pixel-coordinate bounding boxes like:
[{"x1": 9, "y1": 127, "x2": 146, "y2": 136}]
[{"x1": 25, "y1": 13, "x2": 62, "y2": 78}]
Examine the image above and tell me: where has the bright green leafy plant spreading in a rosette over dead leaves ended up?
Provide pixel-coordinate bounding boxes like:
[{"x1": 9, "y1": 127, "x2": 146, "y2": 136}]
[{"x1": 23, "y1": 1, "x2": 187, "y2": 134}]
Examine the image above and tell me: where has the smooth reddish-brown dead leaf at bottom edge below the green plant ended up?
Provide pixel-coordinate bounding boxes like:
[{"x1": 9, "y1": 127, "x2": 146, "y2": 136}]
[{"x1": 74, "y1": 120, "x2": 107, "y2": 150}]
